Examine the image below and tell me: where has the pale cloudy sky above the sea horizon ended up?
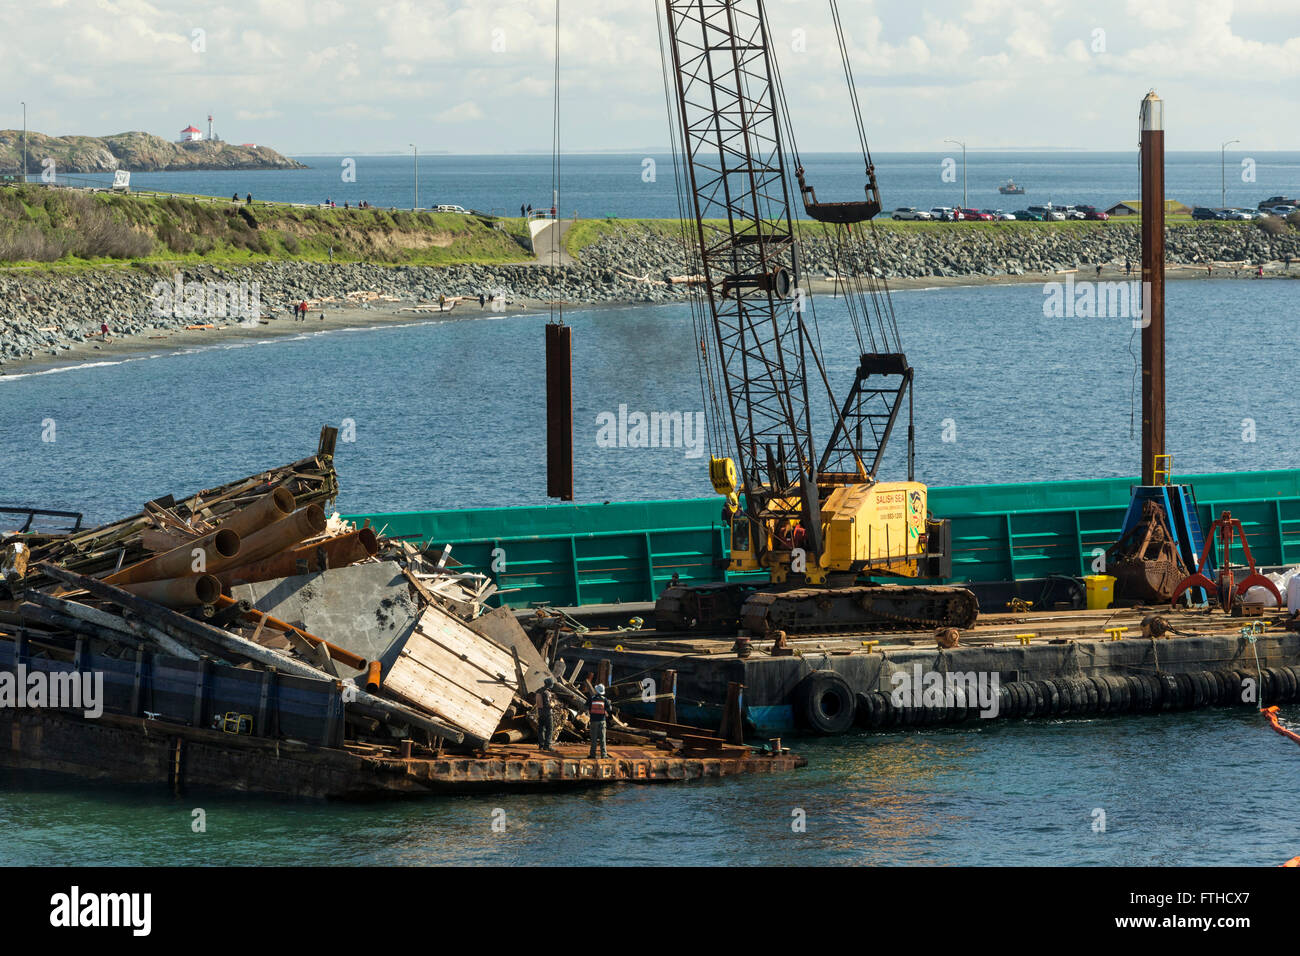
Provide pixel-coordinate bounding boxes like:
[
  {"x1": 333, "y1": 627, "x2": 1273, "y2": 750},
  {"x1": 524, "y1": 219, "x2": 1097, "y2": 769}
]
[{"x1": 0, "y1": 0, "x2": 1300, "y2": 155}]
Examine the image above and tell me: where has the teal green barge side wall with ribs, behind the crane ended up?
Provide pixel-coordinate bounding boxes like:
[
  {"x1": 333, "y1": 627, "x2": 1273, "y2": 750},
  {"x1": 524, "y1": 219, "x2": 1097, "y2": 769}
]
[{"x1": 348, "y1": 470, "x2": 1300, "y2": 607}]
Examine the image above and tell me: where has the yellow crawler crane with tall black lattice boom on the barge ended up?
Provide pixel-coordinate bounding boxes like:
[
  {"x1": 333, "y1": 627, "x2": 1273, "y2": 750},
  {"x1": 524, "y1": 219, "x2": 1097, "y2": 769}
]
[{"x1": 655, "y1": 0, "x2": 979, "y2": 635}]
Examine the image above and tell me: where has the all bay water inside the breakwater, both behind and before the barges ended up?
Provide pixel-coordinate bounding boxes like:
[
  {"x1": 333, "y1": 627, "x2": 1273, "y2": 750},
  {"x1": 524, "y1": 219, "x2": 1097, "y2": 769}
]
[{"x1": 0, "y1": 280, "x2": 1300, "y2": 865}]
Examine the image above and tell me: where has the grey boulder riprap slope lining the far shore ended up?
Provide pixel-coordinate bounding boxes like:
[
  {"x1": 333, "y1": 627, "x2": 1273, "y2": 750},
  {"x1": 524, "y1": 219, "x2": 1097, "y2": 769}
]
[{"x1": 0, "y1": 225, "x2": 1300, "y2": 364}]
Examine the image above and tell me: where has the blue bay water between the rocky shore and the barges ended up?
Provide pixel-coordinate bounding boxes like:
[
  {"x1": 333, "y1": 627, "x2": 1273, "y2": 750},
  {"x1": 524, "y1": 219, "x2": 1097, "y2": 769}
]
[{"x1": 0, "y1": 280, "x2": 1300, "y2": 520}]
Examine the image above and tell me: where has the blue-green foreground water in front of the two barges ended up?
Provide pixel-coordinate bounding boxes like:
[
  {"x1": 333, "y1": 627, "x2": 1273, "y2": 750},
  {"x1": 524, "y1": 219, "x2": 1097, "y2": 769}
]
[{"x1": 0, "y1": 710, "x2": 1300, "y2": 866}]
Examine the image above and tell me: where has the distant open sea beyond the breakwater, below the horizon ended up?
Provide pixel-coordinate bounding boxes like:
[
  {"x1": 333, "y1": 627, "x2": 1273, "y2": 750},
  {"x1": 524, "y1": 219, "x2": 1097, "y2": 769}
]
[{"x1": 53, "y1": 148, "x2": 1300, "y2": 219}]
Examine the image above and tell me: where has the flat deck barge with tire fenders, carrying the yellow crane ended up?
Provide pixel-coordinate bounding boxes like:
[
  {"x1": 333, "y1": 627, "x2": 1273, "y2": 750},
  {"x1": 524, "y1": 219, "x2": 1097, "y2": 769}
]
[{"x1": 560, "y1": 609, "x2": 1300, "y2": 737}]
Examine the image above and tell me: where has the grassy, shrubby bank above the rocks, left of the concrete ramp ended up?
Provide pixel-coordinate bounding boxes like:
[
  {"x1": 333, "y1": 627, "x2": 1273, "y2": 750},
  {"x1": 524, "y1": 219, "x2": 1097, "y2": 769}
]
[{"x1": 0, "y1": 185, "x2": 530, "y2": 269}]
